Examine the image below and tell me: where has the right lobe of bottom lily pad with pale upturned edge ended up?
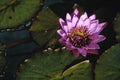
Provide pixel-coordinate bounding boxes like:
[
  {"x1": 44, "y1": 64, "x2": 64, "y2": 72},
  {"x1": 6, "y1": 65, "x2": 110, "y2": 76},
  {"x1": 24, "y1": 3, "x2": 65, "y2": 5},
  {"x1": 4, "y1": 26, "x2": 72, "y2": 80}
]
[{"x1": 63, "y1": 60, "x2": 93, "y2": 80}]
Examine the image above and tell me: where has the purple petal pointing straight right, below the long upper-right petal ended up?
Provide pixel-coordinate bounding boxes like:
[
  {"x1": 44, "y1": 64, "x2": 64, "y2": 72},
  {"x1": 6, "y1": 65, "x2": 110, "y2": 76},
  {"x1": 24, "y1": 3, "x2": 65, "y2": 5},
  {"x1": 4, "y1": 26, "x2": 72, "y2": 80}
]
[{"x1": 90, "y1": 34, "x2": 106, "y2": 43}]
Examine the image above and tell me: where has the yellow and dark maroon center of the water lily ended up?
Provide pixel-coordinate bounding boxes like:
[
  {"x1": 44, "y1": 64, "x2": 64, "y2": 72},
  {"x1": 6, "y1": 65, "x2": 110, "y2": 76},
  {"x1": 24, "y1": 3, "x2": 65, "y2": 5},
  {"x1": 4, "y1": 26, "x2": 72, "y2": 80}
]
[{"x1": 69, "y1": 28, "x2": 90, "y2": 47}]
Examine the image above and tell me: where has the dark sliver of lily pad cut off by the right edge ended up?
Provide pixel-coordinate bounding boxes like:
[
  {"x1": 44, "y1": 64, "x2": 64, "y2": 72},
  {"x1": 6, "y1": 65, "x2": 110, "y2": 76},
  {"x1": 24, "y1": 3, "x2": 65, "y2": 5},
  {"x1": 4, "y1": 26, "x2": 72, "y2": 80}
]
[{"x1": 114, "y1": 13, "x2": 120, "y2": 42}]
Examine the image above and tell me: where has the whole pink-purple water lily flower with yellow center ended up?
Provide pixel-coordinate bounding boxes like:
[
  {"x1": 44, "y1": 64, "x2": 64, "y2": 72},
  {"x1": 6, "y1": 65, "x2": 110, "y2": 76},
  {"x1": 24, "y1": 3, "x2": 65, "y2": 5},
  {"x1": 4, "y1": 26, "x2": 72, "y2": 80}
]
[{"x1": 57, "y1": 9, "x2": 107, "y2": 57}]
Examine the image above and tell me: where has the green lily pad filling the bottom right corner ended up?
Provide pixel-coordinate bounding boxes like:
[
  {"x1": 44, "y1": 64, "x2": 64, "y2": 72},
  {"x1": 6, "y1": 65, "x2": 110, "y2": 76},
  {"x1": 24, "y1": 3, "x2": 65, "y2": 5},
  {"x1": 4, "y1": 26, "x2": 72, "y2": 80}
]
[{"x1": 95, "y1": 44, "x2": 120, "y2": 80}]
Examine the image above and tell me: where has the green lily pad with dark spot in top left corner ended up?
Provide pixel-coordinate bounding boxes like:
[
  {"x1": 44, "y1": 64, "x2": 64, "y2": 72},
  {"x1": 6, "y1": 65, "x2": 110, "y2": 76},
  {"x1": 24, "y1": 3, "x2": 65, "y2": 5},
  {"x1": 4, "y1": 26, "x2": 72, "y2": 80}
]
[{"x1": 0, "y1": 0, "x2": 42, "y2": 29}]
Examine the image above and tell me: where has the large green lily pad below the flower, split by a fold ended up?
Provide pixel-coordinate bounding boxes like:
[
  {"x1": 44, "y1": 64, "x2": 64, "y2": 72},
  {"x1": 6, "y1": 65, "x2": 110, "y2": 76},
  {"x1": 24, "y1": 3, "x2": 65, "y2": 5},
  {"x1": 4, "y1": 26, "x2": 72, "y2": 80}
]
[{"x1": 17, "y1": 50, "x2": 92, "y2": 80}]
